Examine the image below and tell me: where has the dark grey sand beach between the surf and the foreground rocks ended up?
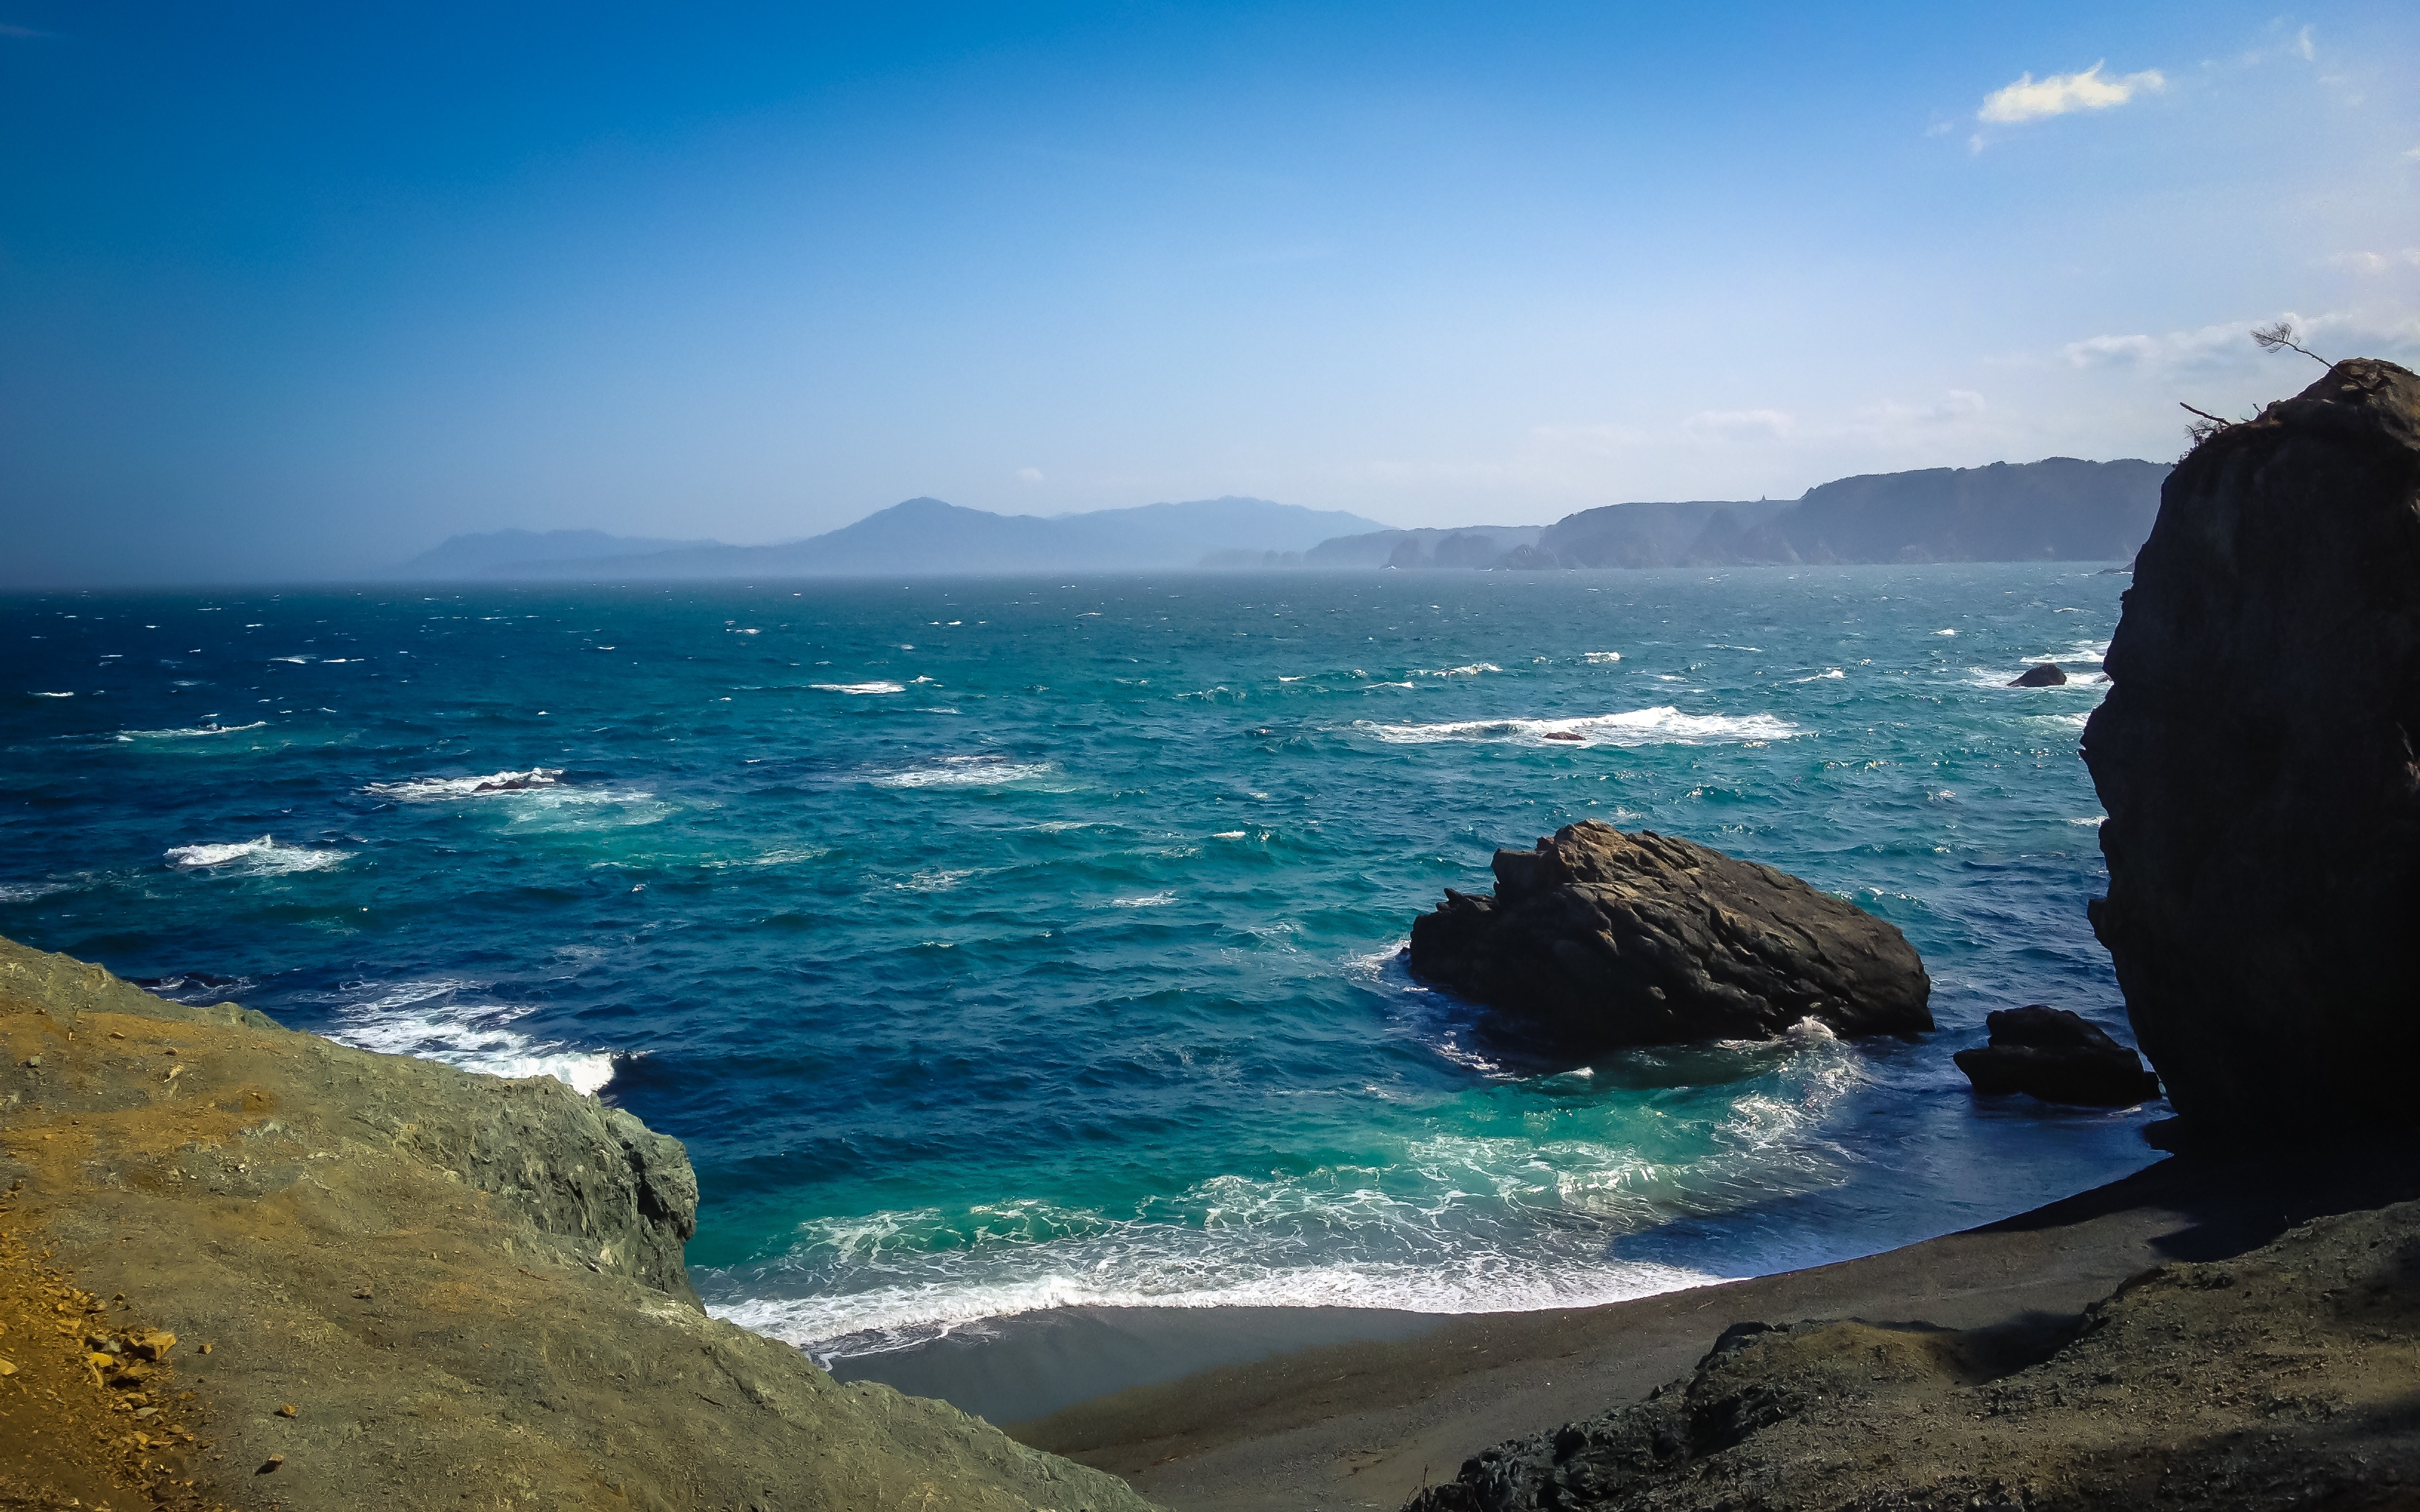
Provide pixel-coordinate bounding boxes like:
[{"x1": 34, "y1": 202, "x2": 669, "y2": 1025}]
[{"x1": 919, "y1": 1149, "x2": 2420, "y2": 1512}]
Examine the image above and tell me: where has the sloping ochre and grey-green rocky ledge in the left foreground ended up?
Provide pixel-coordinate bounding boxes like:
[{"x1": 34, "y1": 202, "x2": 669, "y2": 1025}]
[{"x1": 0, "y1": 941, "x2": 1147, "y2": 1512}]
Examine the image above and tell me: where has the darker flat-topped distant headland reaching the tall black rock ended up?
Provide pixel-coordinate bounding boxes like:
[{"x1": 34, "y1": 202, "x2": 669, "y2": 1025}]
[{"x1": 1304, "y1": 457, "x2": 2169, "y2": 568}]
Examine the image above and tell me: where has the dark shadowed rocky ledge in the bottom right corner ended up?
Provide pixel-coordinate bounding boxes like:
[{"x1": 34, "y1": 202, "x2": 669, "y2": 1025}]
[{"x1": 1409, "y1": 1202, "x2": 2420, "y2": 1512}]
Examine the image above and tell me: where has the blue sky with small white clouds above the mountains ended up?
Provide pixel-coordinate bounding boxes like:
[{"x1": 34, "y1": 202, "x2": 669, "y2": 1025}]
[{"x1": 0, "y1": 0, "x2": 2420, "y2": 588}]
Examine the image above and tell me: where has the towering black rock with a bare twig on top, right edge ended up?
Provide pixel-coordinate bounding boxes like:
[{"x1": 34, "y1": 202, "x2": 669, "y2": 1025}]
[{"x1": 2083, "y1": 360, "x2": 2420, "y2": 1137}]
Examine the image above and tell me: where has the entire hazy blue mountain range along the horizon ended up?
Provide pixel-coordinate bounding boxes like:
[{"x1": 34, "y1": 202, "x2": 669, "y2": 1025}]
[{"x1": 392, "y1": 457, "x2": 2169, "y2": 580}]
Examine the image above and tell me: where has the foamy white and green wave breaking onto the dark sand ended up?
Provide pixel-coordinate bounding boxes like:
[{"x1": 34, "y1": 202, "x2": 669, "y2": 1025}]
[{"x1": 699, "y1": 1026, "x2": 1863, "y2": 1359}]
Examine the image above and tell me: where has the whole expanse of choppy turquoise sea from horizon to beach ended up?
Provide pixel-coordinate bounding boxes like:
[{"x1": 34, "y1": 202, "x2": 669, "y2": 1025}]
[{"x1": 0, "y1": 564, "x2": 2158, "y2": 1355}]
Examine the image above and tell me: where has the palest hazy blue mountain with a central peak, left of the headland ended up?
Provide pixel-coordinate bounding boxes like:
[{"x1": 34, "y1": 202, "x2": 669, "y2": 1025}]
[{"x1": 401, "y1": 498, "x2": 1384, "y2": 580}]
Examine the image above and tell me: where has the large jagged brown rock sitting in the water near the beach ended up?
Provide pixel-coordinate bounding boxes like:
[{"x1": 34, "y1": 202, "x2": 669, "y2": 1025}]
[{"x1": 1411, "y1": 820, "x2": 1934, "y2": 1055}]
